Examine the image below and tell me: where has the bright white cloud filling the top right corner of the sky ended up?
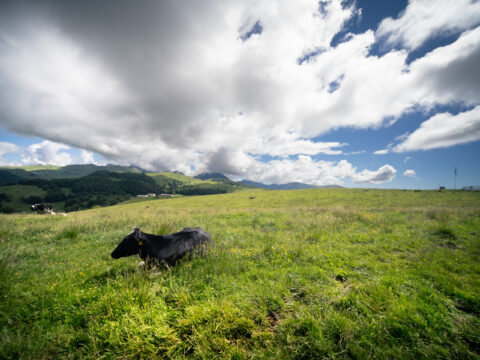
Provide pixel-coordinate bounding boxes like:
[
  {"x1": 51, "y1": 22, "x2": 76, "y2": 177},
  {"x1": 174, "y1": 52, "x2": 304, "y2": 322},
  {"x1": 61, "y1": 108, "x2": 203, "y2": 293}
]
[{"x1": 377, "y1": 0, "x2": 480, "y2": 49}]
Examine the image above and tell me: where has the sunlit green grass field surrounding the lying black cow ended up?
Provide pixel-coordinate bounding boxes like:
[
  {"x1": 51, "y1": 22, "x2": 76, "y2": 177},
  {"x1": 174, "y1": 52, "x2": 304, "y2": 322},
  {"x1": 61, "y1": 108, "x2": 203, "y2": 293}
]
[{"x1": 0, "y1": 189, "x2": 480, "y2": 359}]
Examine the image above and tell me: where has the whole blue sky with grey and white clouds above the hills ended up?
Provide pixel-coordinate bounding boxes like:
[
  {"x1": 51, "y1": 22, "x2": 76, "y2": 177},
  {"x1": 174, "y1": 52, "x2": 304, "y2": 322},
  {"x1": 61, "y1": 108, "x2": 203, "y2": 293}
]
[{"x1": 0, "y1": 0, "x2": 480, "y2": 189}]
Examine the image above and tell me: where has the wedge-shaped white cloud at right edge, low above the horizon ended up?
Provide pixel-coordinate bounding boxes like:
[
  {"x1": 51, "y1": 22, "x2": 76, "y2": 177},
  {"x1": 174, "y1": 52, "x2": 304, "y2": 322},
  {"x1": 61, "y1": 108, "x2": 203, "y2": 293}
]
[{"x1": 393, "y1": 106, "x2": 480, "y2": 152}]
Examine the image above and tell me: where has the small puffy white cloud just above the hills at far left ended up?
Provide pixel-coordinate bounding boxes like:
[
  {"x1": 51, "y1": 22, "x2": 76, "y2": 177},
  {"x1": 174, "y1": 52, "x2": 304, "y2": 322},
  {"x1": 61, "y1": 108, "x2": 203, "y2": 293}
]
[{"x1": 22, "y1": 140, "x2": 73, "y2": 166}]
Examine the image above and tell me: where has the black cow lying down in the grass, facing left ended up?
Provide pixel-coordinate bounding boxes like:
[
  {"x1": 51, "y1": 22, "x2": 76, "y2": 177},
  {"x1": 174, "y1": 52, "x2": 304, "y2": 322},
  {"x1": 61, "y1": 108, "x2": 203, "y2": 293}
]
[{"x1": 112, "y1": 227, "x2": 212, "y2": 266}]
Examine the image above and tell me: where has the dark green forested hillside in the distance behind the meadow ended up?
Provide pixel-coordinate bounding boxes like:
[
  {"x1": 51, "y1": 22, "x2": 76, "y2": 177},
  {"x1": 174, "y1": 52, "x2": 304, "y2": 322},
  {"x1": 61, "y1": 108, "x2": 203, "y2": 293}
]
[{"x1": 0, "y1": 170, "x2": 255, "y2": 213}]
